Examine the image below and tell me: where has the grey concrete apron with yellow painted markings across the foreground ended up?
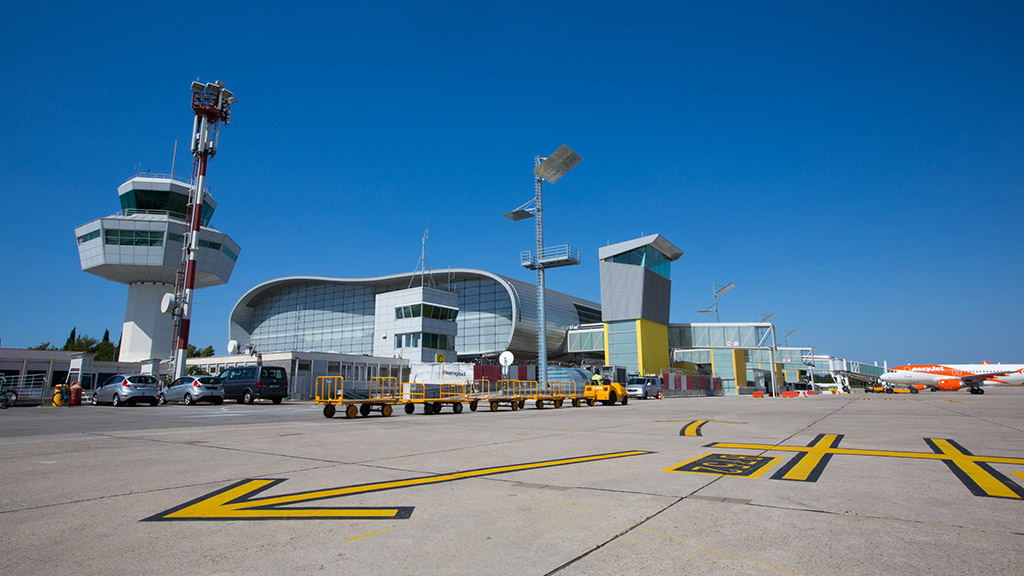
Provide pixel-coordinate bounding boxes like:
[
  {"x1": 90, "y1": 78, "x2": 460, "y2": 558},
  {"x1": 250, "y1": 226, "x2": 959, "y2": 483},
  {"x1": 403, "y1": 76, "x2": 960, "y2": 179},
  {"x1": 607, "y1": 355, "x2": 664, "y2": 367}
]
[{"x1": 0, "y1": 387, "x2": 1024, "y2": 575}]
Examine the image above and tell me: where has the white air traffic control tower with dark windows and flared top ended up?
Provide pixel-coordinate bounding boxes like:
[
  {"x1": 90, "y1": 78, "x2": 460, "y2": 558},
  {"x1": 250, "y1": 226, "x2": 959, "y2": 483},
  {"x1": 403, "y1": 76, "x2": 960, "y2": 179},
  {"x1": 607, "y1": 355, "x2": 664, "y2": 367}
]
[{"x1": 75, "y1": 174, "x2": 240, "y2": 362}]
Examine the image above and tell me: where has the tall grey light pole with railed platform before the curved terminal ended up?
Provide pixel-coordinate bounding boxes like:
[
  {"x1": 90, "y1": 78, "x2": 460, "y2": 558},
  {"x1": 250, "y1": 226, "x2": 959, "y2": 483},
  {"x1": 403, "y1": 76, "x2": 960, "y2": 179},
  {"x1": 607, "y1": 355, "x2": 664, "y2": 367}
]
[{"x1": 504, "y1": 145, "x2": 583, "y2": 384}]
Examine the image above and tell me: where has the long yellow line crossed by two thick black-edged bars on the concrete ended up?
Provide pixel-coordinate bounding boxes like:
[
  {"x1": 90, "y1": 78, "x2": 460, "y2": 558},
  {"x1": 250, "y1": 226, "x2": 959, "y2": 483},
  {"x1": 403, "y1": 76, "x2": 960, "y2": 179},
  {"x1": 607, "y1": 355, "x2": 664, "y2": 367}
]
[{"x1": 708, "y1": 434, "x2": 1024, "y2": 500}]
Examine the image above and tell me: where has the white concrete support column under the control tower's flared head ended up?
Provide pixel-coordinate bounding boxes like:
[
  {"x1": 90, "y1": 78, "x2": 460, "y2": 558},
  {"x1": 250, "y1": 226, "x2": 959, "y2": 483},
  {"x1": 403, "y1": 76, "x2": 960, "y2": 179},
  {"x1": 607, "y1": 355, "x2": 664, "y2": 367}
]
[{"x1": 118, "y1": 283, "x2": 174, "y2": 362}]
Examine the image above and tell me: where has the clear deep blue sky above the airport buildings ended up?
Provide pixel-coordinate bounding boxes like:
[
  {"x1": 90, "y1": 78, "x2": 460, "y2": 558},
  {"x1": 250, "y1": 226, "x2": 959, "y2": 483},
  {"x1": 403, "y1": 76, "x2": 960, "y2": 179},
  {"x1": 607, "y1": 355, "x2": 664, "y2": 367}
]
[{"x1": 0, "y1": 1, "x2": 1024, "y2": 365}]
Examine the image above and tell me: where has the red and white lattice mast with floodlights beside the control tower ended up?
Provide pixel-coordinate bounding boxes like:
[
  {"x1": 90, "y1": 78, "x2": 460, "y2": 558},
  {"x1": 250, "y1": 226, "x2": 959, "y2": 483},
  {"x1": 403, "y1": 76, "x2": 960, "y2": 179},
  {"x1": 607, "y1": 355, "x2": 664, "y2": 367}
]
[{"x1": 174, "y1": 80, "x2": 238, "y2": 378}]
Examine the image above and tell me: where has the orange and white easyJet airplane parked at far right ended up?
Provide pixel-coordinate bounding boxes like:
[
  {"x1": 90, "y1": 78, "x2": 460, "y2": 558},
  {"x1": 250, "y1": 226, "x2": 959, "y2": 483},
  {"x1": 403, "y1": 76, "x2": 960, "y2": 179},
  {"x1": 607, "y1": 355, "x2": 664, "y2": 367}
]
[{"x1": 880, "y1": 362, "x2": 1024, "y2": 394}]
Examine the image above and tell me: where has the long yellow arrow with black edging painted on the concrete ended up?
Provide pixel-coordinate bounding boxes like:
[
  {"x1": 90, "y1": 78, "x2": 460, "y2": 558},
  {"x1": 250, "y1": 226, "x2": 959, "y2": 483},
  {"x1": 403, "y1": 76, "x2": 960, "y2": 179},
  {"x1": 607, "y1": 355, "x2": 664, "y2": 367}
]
[{"x1": 143, "y1": 450, "x2": 650, "y2": 522}]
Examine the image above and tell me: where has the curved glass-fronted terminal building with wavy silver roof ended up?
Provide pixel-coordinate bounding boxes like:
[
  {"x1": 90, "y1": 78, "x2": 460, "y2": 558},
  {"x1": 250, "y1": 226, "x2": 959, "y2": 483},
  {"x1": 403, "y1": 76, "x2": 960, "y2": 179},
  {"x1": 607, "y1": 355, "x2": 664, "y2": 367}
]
[{"x1": 229, "y1": 269, "x2": 600, "y2": 360}]
